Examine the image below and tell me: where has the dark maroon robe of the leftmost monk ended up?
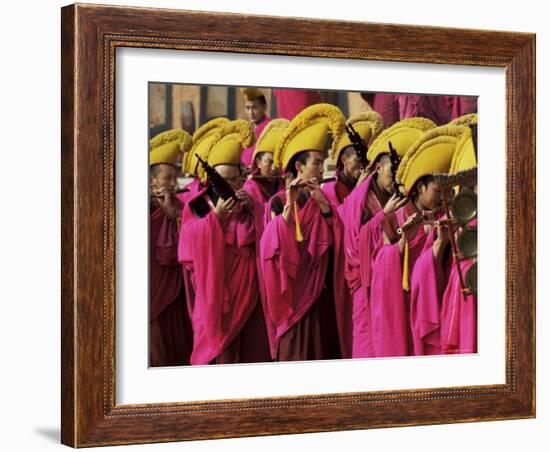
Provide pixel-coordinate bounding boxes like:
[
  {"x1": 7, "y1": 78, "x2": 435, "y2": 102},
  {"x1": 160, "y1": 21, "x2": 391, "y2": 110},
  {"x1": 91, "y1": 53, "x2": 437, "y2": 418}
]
[{"x1": 149, "y1": 201, "x2": 193, "y2": 366}]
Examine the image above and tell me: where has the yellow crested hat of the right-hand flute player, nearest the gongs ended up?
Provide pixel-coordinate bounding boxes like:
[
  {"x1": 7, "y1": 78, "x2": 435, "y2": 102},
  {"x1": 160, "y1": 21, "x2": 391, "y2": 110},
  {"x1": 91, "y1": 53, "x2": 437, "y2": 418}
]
[{"x1": 396, "y1": 125, "x2": 468, "y2": 195}]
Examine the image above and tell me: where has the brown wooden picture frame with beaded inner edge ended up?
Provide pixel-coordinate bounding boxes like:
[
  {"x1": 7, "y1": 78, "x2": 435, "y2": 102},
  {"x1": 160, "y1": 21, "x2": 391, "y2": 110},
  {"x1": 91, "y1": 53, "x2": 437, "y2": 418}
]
[{"x1": 61, "y1": 5, "x2": 535, "y2": 447}]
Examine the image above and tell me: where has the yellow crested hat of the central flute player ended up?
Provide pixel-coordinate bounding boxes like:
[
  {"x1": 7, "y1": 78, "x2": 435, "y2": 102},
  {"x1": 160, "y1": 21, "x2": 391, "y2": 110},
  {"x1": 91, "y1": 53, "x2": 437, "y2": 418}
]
[{"x1": 273, "y1": 104, "x2": 345, "y2": 171}]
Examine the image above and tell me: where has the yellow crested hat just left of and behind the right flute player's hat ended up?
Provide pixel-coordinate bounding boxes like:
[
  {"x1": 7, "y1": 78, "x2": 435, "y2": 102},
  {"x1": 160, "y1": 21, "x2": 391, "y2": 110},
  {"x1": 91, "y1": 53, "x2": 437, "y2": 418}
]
[{"x1": 367, "y1": 117, "x2": 435, "y2": 164}]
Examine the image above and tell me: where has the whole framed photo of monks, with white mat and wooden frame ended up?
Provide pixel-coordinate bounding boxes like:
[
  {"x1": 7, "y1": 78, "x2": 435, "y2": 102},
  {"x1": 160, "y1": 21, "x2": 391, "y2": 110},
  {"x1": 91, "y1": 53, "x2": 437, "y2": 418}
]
[{"x1": 62, "y1": 4, "x2": 535, "y2": 447}]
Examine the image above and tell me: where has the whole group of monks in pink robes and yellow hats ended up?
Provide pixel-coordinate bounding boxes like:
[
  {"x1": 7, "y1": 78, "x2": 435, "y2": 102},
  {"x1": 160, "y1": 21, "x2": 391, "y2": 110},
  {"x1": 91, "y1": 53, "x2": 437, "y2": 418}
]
[{"x1": 149, "y1": 88, "x2": 477, "y2": 366}]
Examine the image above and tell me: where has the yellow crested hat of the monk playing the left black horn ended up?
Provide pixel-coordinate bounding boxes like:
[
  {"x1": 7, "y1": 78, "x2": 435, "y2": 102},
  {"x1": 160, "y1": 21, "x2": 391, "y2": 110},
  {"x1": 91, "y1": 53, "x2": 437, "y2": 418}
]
[{"x1": 199, "y1": 119, "x2": 254, "y2": 179}]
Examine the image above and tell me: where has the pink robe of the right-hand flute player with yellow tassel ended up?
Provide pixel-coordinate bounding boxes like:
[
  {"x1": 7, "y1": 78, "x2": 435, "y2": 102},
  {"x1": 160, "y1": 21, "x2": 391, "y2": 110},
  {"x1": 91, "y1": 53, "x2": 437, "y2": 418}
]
[{"x1": 370, "y1": 202, "x2": 434, "y2": 357}]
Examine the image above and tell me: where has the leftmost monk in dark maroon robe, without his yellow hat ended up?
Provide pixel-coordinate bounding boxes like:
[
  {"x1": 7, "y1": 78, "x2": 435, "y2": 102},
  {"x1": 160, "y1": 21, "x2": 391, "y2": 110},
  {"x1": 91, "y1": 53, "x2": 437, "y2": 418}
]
[{"x1": 149, "y1": 163, "x2": 193, "y2": 366}]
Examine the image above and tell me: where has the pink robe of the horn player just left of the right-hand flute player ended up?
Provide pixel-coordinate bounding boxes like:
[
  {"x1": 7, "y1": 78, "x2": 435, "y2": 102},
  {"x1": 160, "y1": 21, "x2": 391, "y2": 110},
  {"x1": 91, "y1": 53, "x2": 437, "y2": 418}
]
[{"x1": 339, "y1": 174, "x2": 398, "y2": 358}]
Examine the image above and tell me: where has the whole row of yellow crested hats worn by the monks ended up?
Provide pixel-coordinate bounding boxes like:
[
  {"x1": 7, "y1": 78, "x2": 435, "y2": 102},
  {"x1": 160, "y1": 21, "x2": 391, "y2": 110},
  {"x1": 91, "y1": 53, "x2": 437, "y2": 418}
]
[{"x1": 150, "y1": 104, "x2": 477, "y2": 192}]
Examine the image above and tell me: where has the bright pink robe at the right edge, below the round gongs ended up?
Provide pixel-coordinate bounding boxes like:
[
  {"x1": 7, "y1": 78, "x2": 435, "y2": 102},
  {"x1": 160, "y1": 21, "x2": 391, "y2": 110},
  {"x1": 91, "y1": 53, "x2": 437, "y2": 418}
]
[{"x1": 441, "y1": 220, "x2": 477, "y2": 354}]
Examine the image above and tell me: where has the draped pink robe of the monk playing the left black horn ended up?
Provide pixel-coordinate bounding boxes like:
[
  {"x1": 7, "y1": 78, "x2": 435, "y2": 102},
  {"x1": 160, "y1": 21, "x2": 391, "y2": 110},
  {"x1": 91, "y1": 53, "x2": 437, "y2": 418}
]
[{"x1": 178, "y1": 188, "x2": 269, "y2": 364}]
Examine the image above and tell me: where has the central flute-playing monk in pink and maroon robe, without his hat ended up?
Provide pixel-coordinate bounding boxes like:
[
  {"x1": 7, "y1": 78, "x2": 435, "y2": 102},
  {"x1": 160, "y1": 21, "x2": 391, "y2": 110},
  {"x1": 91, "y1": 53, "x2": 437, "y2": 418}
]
[{"x1": 260, "y1": 152, "x2": 341, "y2": 361}]
